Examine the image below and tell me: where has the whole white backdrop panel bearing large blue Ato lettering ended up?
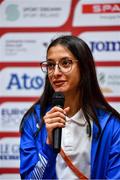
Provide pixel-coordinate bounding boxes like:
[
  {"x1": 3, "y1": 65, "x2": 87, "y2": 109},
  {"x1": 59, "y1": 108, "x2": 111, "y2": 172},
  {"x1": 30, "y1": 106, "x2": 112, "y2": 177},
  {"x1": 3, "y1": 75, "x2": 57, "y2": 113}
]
[{"x1": 0, "y1": 67, "x2": 45, "y2": 97}]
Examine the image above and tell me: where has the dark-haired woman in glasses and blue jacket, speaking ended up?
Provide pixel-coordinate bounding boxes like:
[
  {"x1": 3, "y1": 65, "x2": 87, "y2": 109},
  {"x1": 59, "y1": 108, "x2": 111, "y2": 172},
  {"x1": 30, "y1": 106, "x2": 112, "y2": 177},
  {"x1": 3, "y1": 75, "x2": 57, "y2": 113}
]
[{"x1": 20, "y1": 35, "x2": 120, "y2": 179}]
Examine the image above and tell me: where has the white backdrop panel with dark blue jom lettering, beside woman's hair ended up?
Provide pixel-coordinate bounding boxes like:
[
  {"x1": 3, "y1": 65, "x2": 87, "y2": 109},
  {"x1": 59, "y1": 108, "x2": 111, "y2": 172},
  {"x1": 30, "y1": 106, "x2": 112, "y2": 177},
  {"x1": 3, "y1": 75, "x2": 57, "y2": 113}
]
[{"x1": 79, "y1": 31, "x2": 120, "y2": 61}]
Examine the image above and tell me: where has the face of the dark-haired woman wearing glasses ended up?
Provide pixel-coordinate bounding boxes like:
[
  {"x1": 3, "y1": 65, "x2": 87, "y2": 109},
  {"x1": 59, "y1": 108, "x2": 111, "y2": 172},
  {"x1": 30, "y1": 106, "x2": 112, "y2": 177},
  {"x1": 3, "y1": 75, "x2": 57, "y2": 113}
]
[{"x1": 47, "y1": 45, "x2": 80, "y2": 95}]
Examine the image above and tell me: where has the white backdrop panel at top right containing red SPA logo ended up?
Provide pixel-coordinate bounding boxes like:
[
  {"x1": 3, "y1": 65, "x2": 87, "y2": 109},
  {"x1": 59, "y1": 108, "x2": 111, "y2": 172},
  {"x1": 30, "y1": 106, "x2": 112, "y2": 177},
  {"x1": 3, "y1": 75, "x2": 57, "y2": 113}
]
[{"x1": 73, "y1": 0, "x2": 120, "y2": 27}]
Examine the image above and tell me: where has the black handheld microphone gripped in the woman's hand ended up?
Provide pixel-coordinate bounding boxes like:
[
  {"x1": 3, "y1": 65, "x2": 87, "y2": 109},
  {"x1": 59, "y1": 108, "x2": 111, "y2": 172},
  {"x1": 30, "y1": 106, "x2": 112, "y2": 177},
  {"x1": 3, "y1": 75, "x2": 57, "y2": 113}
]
[{"x1": 52, "y1": 92, "x2": 65, "y2": 153}]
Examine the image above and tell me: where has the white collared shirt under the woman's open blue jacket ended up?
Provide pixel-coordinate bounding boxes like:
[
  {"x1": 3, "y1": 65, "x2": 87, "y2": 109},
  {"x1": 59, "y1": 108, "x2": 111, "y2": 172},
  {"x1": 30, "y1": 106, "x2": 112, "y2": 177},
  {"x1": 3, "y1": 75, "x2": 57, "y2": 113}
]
[{"x1": 56, "y1": 110, "x2": 92, "y2": 180}]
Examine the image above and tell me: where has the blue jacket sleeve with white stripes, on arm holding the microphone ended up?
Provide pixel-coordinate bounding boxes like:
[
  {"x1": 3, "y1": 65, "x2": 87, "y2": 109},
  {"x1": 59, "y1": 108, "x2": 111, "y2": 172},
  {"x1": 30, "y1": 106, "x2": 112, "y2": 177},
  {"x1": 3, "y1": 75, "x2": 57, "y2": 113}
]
[{"x1": 20, "y1": 116, "x2": 57, "y2": 179}]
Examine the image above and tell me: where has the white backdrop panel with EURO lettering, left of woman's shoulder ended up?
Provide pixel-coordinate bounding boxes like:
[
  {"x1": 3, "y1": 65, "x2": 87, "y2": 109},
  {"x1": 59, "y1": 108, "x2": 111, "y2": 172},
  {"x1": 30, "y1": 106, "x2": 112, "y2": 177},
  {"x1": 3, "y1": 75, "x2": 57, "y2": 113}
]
[{"x1": 0, "y1": 102, "x2": 32, "y2": 132}]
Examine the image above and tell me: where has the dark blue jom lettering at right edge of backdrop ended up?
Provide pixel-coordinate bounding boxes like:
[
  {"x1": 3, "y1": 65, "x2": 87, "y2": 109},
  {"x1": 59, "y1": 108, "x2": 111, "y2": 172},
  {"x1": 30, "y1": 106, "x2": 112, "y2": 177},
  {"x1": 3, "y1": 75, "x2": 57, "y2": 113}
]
[{"x1": 90, "y1": 41, "x2": 120, "y2": 52}]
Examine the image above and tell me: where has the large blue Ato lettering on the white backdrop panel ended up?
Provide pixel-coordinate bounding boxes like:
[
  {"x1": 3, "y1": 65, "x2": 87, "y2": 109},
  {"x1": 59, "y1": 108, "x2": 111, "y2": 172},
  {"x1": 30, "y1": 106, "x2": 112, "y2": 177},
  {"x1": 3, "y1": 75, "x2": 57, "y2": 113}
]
[{"x1": 7, "y1": 73, "x2": 44, "y2": 90}]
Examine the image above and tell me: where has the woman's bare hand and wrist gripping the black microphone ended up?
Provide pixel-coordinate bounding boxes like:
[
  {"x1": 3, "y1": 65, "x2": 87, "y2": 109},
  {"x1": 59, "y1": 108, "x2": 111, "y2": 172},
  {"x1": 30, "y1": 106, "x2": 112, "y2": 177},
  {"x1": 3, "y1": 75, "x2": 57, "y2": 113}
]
[{"x1": 43, "y1": 106, "x2": 70, "y2": 144}]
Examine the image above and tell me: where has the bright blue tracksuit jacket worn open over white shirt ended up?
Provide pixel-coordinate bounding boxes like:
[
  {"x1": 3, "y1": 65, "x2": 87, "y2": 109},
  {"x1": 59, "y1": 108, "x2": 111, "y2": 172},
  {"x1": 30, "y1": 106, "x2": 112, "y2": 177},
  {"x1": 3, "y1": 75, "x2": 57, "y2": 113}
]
[{"x1": 20, "y1": 105, "x2": 120, "y2": 179}]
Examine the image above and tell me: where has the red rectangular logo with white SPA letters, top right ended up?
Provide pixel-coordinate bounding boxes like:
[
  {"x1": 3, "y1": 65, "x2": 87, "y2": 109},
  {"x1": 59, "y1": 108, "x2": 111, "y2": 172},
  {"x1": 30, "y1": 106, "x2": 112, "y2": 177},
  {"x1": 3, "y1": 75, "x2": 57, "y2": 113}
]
[{"x1": 82, "y1": 3, "x2": 120, "y2": 14}]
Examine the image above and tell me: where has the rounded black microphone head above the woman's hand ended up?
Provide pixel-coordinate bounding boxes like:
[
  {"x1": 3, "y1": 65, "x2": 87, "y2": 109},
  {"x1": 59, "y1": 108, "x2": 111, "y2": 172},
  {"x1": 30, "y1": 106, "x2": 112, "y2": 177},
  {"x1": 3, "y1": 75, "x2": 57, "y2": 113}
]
[{"x1": 52, "y1": 92, "x2": 65, "y2": 108}]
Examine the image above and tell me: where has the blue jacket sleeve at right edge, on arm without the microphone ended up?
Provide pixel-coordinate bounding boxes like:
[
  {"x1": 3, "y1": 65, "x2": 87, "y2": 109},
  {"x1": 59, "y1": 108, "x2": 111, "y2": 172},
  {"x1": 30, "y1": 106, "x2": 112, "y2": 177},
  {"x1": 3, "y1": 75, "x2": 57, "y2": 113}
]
[{"x1": 107, "y1": 116, "x2": 120, "y2": 179}]
